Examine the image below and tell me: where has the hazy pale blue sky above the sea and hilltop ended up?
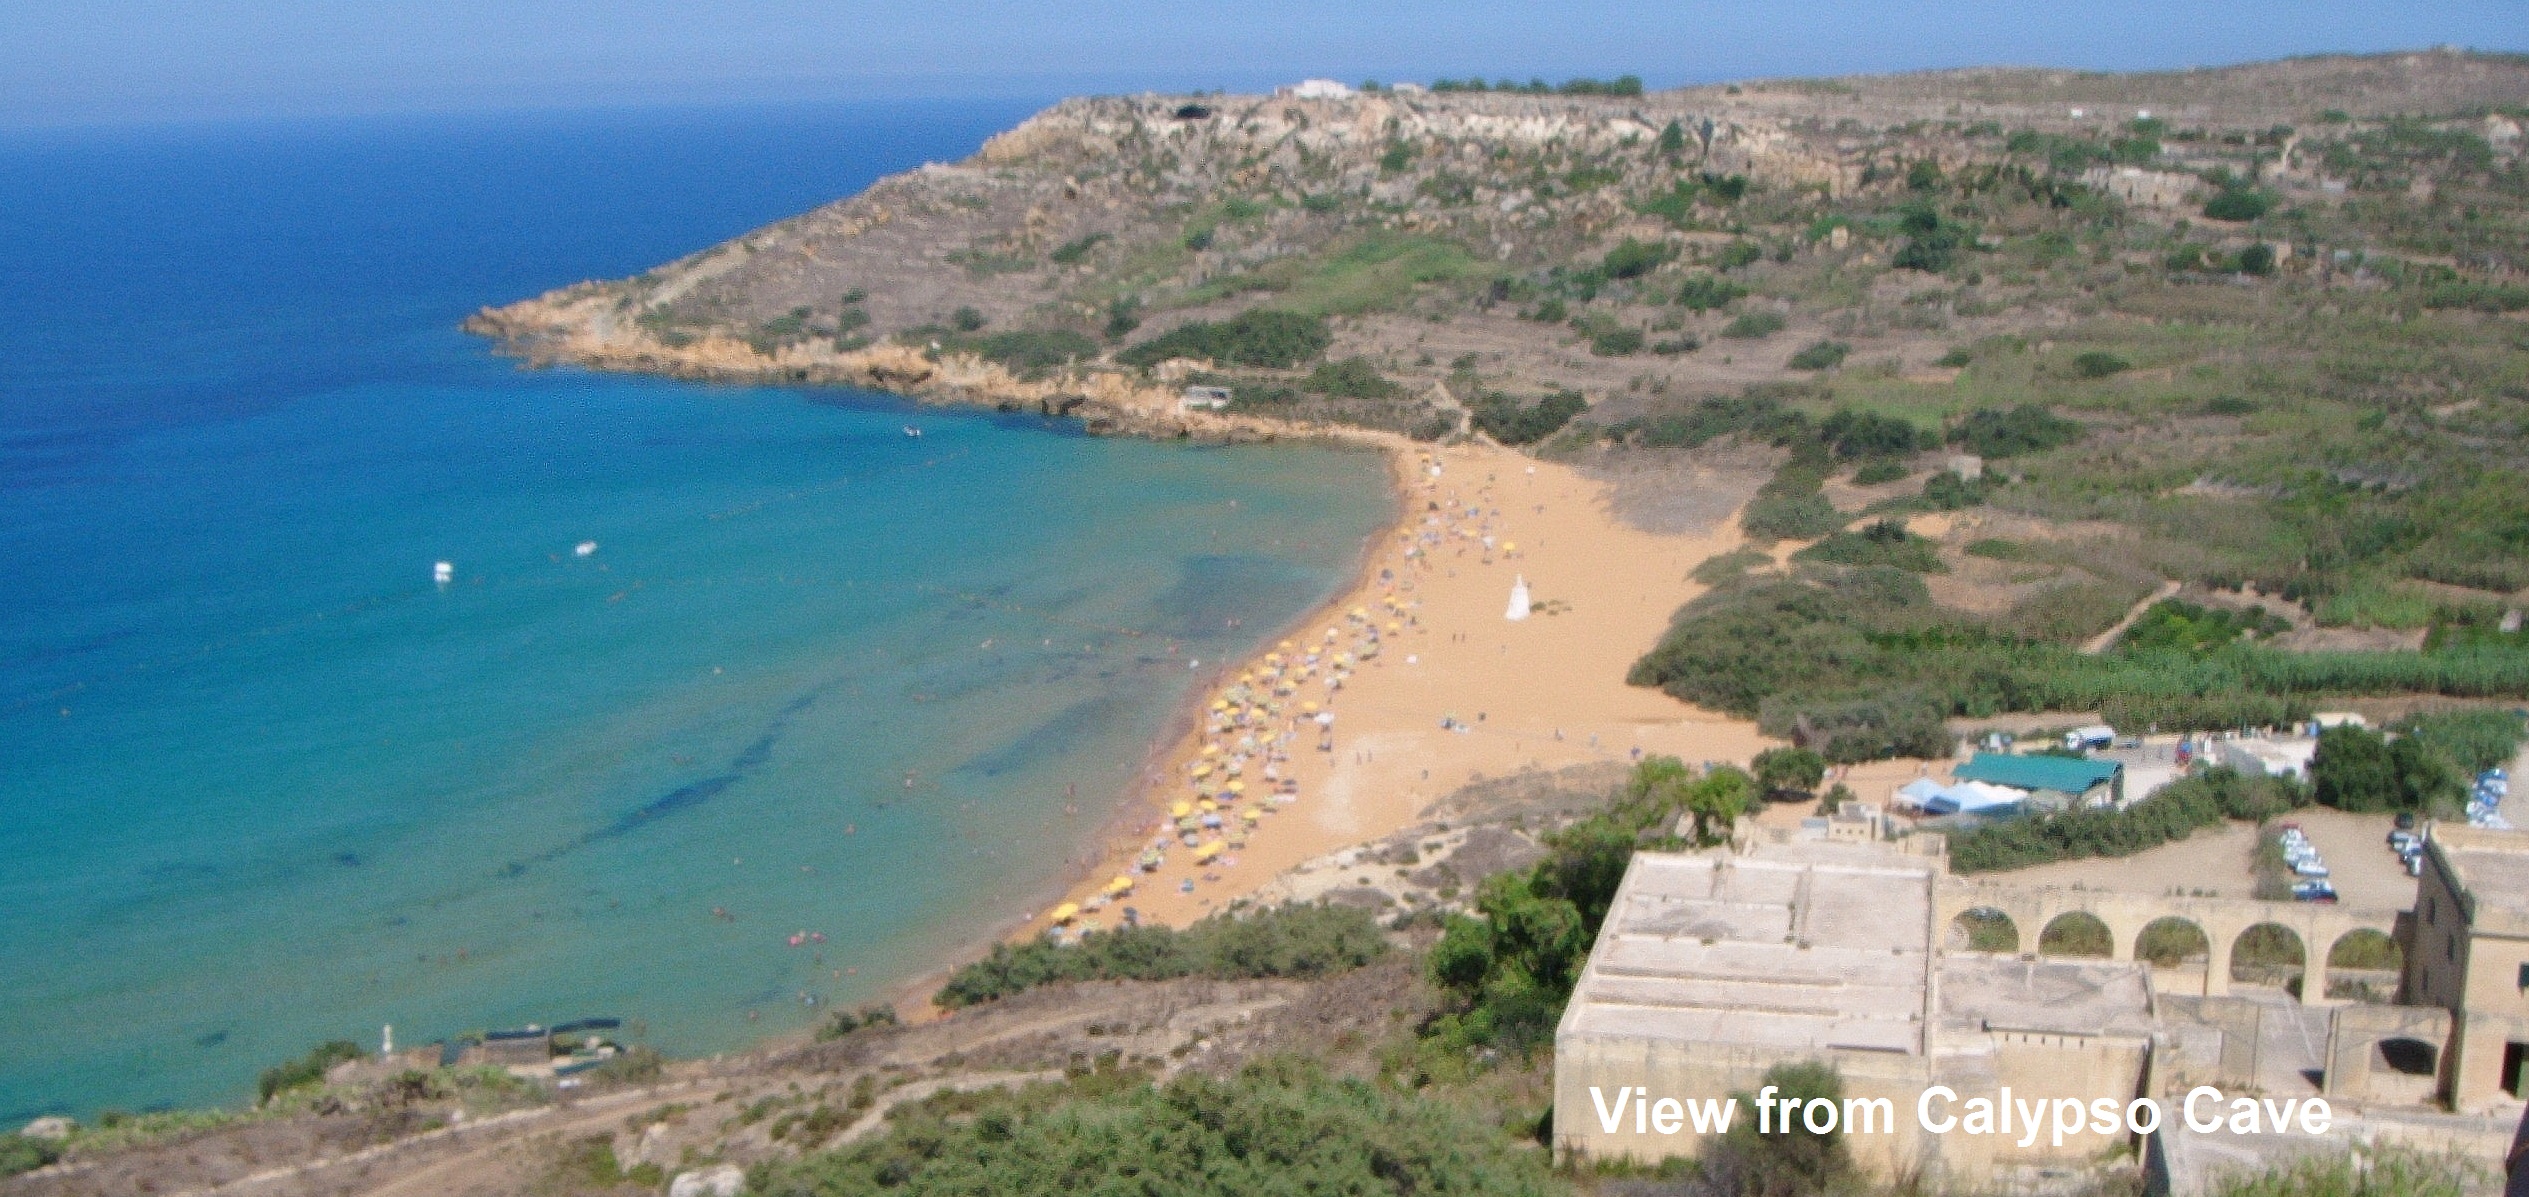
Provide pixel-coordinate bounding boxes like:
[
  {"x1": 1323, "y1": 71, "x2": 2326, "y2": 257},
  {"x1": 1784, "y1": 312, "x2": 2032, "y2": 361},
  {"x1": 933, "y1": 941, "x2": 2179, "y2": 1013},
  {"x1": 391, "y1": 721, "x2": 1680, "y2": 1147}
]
[{"x1": 14, "y1": 0, "x2": 2529, "y2": 127}]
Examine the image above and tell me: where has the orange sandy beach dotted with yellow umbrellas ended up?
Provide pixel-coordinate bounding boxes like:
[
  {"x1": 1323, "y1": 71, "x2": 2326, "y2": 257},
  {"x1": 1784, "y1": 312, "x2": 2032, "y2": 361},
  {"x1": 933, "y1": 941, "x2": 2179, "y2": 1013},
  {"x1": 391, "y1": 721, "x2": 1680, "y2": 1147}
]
[{"x1": 1022, "y1": 440, "x2": 1768, "y2": 934}]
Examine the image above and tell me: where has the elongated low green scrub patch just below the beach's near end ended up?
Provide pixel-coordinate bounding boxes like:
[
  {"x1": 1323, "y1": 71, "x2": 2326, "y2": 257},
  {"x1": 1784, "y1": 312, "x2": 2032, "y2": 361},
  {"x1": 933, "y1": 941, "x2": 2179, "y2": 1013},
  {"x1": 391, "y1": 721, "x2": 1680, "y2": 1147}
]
[{"x1": 933, "y1": 906, "x2": 1388, "y2": 1010}]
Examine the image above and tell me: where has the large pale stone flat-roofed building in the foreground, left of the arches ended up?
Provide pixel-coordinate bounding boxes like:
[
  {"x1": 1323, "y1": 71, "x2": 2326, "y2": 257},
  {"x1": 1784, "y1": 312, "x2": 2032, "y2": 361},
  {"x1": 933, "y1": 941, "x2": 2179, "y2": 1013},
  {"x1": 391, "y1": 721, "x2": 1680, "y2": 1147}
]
[{"x1": 1555, "y1": 840, "x2": 2150, "y2": 1177}]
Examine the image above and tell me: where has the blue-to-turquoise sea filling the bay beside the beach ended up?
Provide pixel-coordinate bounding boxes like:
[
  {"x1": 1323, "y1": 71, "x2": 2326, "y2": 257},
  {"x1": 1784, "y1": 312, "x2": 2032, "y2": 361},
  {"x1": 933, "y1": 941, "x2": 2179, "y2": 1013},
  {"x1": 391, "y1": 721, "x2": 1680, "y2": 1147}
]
[{"x1": 0, "y1": 101, "x2": 1388, "y2": 1126}]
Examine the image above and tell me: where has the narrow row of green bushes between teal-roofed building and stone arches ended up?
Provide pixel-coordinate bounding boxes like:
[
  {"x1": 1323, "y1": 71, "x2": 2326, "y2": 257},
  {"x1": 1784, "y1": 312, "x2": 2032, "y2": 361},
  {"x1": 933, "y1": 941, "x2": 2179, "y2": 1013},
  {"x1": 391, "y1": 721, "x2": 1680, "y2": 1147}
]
[{"x1": 1950, "y1": 769, "x2": 2309, "y2": 873}]
